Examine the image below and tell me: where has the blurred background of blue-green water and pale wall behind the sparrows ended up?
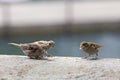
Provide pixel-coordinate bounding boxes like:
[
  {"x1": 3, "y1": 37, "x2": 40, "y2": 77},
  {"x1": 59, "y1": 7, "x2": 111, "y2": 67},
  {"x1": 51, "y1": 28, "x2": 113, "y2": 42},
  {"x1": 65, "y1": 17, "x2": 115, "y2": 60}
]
[{"x1": 0, "y1": 0, "x2": 120, "y2": 58}]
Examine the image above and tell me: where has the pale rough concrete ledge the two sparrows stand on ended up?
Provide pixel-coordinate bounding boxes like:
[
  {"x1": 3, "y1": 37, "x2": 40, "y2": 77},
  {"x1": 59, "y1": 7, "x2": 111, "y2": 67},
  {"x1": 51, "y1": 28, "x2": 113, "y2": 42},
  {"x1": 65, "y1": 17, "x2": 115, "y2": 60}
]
[{"x1": 0, "y1": 55, "x2": 120, "y2": 80}]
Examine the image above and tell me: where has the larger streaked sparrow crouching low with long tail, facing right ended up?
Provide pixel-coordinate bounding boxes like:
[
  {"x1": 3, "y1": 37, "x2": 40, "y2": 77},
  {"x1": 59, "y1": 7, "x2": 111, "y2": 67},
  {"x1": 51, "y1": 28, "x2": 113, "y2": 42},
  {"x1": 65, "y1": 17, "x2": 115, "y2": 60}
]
[{"x1": 9, "y1": 40, "x2": 55, "y2": 59}]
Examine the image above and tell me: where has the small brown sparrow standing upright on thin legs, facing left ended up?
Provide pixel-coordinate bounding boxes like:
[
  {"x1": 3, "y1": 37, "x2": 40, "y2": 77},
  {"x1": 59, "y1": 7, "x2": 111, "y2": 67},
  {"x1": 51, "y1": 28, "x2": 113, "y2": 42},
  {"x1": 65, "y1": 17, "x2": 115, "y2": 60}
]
[{"x1": 80, "y1": 41, "x2": 102, "y2": 59}]
